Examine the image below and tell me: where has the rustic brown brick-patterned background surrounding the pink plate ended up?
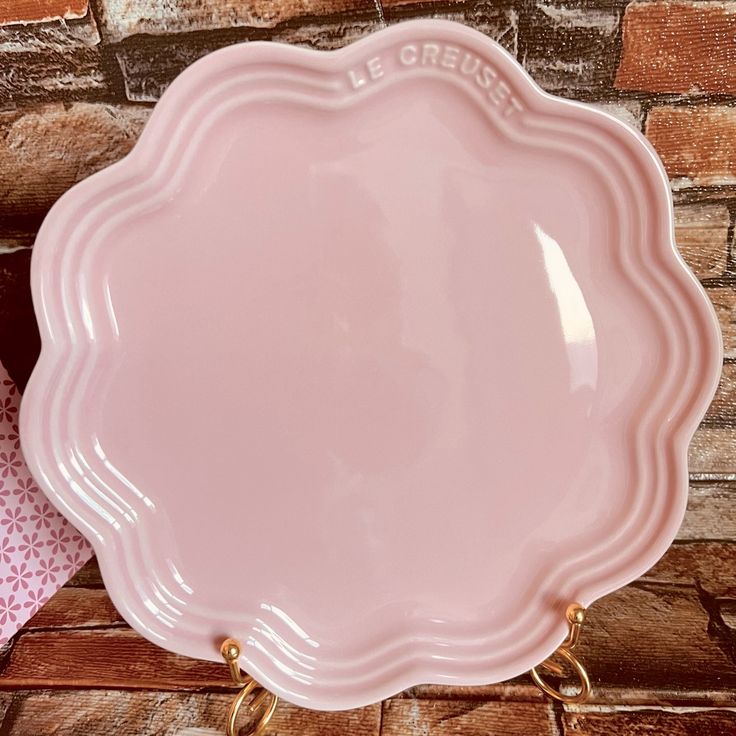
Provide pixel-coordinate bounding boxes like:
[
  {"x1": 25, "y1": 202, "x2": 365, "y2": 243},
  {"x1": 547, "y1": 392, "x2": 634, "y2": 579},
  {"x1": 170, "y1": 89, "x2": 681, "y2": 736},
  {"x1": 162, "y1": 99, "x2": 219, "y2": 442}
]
[{"x1": 0, "y1": 0, "x2": 736, "y2": 736}]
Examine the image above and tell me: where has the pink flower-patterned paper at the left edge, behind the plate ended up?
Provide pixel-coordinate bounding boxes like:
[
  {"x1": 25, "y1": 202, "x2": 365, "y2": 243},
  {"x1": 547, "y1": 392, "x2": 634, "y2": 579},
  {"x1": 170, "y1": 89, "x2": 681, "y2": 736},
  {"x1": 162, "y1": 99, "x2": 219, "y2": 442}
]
[{"x1": 0, "y1": 365, "x2": 92, "y2": 646}]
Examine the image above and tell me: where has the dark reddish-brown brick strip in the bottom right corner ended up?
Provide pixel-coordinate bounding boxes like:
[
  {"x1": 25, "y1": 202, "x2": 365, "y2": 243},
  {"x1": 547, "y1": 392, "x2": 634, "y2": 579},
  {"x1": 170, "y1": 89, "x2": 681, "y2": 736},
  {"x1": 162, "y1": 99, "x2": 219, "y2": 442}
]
[{"x1": 562, "y1": 707, "x2": 736, "y2": 736}]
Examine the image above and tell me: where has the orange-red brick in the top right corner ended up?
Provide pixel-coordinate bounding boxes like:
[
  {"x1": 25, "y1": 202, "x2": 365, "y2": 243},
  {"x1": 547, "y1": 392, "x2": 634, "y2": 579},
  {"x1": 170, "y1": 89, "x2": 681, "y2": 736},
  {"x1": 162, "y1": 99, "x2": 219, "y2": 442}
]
[{"x1": 615, "y1": 0, "x2": 736, "y2": 94}]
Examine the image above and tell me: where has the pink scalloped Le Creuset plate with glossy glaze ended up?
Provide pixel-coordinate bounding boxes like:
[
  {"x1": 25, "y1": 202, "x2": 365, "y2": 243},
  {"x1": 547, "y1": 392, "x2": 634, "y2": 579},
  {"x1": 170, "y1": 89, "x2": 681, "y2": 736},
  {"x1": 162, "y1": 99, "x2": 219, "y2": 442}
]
[{"x1": 22, "y1": 21, "x2": 721, "y2": 709}]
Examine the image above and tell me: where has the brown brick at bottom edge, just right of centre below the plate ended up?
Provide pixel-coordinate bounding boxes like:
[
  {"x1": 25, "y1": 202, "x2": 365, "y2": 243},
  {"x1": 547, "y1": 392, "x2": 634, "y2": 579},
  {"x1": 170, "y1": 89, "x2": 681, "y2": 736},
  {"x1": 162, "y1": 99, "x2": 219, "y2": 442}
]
[{"x1": 381, "y1": 699, "x2": 558, "y2": 736}]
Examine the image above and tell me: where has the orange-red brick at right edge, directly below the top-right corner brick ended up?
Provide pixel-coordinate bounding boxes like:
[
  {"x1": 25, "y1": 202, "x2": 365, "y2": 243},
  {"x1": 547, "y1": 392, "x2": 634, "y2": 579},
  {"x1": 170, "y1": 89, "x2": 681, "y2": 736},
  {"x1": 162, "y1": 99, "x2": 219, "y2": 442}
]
[{"x1": 646, "y1": 105, "x2": 736, "y2": 186}]
